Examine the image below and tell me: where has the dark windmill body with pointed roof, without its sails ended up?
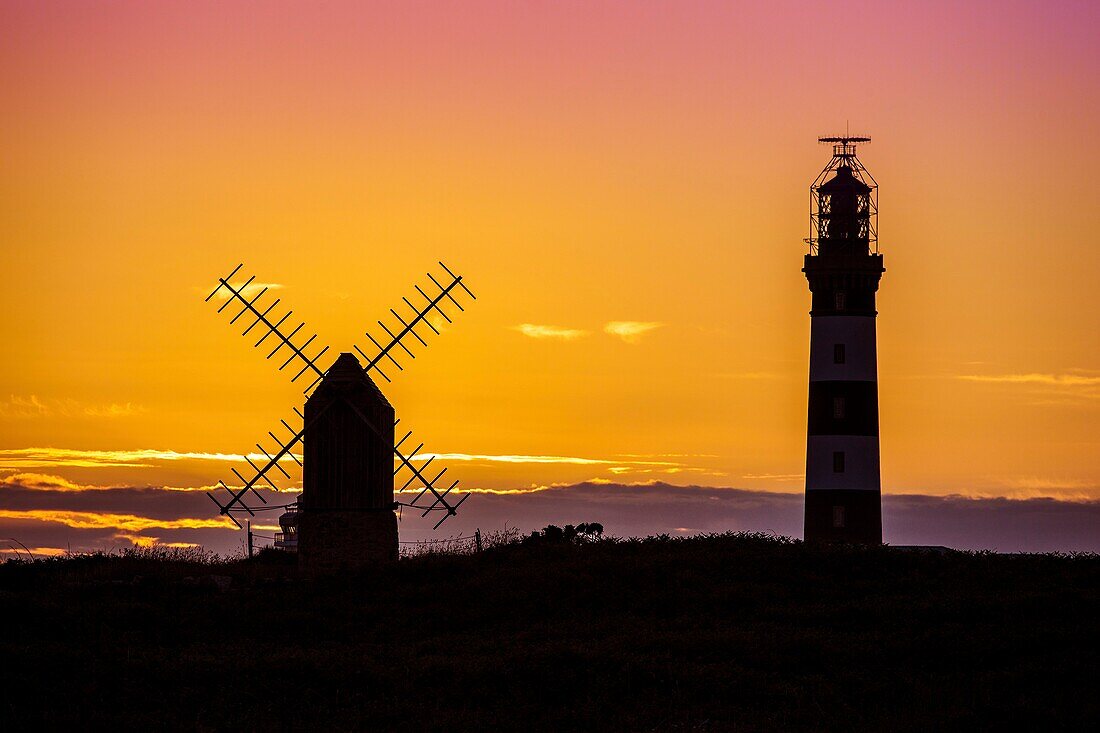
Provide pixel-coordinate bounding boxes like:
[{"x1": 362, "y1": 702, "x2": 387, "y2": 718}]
[{"x1": 296, "y1": 353, "x2": 397, "y2": 569}]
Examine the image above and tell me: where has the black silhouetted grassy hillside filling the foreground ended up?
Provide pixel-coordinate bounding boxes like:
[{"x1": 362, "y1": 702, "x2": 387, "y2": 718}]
[{"x1": 0, "y1": 535, "x2": 1100, "y2": 731}]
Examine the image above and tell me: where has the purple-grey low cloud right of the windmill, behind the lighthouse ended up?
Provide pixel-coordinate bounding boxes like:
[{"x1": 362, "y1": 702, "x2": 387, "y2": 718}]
[{"x1": 402, "y1": 481, "x2": 1100, "y2": 553}]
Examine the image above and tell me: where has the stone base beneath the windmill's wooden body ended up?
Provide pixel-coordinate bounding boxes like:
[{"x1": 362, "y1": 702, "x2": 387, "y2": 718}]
[{"x1": 298, "y1": 508, "x2": 398, "y2": 572}]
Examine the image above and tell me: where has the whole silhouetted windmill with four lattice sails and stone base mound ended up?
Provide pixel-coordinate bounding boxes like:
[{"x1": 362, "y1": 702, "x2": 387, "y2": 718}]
[{"x1": 206, "y1": 262, "x2": 476, "y2": 565}]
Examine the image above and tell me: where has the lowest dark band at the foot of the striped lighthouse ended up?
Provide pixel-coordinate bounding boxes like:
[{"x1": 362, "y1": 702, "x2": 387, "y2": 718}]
[{"x1": 804, "y1": 489, "x2": 882, "y2": 545}]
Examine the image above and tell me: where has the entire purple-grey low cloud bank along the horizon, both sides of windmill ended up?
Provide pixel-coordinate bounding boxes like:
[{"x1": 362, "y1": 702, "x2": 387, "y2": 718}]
[{"x1": 0, "y1": 477, "x2": 1100, "y2": 553}]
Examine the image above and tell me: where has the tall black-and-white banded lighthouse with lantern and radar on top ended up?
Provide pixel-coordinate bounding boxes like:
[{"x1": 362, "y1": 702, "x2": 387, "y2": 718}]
[{"x1": 802, "y1": 136, "x2": 886, "y2": 545}]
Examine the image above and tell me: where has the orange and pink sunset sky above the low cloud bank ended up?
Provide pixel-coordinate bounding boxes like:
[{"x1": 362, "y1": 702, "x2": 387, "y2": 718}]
[{"x1": 0, "y1": 2, "x2": 1100, "y2": 548}]
